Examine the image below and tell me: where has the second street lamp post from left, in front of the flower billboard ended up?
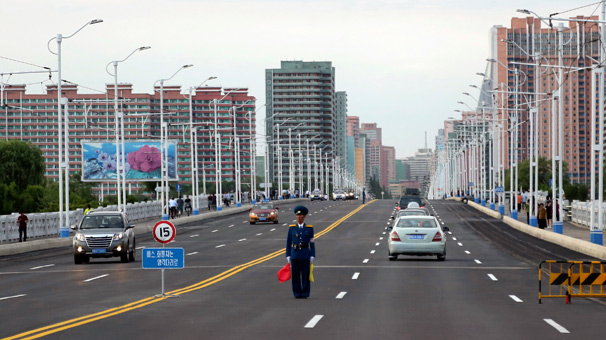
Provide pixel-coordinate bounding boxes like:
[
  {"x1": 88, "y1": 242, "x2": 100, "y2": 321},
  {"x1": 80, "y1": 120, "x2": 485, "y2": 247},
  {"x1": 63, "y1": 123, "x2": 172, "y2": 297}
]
[{"x1": 105, "y1": 46, "x2": 150, "y2": 213}]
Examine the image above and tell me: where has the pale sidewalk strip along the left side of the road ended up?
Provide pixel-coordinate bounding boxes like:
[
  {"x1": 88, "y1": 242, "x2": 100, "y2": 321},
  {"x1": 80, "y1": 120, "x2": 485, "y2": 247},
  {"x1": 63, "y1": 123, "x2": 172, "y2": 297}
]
[{"x1": 0, "y1": 198, "x2": 307, "y2": 256}]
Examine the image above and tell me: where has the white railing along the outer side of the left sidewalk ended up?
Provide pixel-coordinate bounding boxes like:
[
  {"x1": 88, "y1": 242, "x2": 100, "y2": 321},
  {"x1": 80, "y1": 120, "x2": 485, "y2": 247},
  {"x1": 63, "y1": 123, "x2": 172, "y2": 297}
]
[{"x1": 0, "y1": 195, "x2": 221, "y2": 243}]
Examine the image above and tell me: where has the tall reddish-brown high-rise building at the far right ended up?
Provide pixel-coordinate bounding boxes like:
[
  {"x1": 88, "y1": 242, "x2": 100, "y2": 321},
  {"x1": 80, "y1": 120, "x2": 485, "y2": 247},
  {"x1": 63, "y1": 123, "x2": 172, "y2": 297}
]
[{"x1": 494, "y1": 16, "x2": 600, "y2": 183}]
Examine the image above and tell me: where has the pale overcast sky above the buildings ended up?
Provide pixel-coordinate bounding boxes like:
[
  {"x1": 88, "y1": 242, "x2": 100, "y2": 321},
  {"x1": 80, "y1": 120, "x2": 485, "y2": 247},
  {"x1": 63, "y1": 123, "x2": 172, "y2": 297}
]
[{"x1": 0, "y1": 0, "x2": 600, "y2": 158}]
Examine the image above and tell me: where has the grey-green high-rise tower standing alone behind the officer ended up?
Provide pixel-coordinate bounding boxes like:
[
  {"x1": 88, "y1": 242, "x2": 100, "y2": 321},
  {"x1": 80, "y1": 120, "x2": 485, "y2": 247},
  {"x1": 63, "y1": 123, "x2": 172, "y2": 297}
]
[{"x1": 265, "y1": 61, "x2": 340, "y2": 191}]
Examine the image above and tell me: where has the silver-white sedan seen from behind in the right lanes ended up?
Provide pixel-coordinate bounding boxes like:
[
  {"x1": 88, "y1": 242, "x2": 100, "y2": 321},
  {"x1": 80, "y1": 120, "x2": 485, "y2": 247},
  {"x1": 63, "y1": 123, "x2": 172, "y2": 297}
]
[{"x1": 387, "y1": 216, "x2": 449, "y2": 261}]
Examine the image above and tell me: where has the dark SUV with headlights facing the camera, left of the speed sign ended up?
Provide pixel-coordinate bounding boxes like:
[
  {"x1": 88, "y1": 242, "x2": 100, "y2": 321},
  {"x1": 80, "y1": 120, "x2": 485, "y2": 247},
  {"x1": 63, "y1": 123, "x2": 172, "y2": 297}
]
[{"x1": 72, "y1": 211, "x2": 135, "y2": 264}]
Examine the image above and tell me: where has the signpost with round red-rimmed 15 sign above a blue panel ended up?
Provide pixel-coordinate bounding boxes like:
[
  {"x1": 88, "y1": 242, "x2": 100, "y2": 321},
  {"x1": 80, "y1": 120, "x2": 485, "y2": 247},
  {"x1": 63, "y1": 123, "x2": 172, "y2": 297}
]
[{"x1": 141, "y1": 221, "x2": 185, "y2": 297}]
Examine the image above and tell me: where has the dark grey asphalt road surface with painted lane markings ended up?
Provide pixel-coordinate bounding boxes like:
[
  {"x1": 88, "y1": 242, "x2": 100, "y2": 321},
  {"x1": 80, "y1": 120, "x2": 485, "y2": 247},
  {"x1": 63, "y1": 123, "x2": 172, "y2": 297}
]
[{"x1": 0, "y1": 201, "x2": 606, "y2": 339}]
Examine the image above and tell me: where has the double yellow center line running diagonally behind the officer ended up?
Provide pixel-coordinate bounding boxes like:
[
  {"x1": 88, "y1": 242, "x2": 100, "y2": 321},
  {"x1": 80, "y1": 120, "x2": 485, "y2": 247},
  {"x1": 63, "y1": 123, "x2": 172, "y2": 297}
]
[{"x1": 2, "y1": 201, "x2": 374, "y2": 340}]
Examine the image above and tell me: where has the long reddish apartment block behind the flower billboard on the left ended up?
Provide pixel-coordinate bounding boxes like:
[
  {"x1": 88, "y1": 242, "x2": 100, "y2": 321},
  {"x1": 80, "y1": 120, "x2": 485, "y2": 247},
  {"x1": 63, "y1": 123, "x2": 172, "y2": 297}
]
[{"x1": 0, "y1": 84, "x2": 256, "y2": 194}]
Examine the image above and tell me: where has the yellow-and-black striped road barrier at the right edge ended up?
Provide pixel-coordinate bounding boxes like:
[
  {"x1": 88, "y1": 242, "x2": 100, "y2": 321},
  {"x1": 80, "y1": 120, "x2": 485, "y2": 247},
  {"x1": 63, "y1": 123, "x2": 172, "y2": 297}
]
[{"x1": 539, "y1": 260, "x2": 606, "y2": 304}]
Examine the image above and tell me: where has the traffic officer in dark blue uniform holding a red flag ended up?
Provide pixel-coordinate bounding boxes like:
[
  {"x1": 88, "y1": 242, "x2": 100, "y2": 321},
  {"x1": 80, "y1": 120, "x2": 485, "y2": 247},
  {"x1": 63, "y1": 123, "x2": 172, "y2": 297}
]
[{"x1": 286, "y1": 206, "x2": 316, "y2": 299}]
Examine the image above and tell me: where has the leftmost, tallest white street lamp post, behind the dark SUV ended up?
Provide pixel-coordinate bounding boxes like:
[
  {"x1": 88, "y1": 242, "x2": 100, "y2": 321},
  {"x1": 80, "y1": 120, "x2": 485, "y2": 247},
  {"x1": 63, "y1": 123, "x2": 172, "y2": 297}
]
[{"x1": 47, "y1": 19, "x2": 103, "y2": 237}]
